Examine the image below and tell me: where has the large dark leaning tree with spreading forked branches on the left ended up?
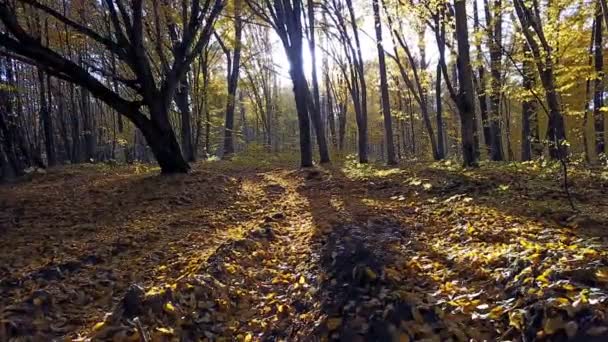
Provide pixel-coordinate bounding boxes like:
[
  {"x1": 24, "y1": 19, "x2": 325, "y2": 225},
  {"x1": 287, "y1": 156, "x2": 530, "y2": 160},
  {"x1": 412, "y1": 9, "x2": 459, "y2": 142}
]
[{"x1": 0, "y1": 0, "x2": 226, "y2": 173}]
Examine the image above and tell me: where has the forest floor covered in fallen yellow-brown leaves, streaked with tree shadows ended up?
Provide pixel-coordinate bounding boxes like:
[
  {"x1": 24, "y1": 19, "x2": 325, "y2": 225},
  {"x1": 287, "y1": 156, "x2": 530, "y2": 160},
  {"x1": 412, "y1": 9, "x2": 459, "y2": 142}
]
[{"x1": 0, "y1": 157, "x2": 608, "y2": 341}]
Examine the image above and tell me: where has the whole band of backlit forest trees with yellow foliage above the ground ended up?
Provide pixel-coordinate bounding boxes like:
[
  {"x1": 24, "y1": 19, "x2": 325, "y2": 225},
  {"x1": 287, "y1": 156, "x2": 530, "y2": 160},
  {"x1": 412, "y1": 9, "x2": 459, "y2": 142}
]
[{"x1": 0, "y1": 0, "x2": 608, "y2": 179}]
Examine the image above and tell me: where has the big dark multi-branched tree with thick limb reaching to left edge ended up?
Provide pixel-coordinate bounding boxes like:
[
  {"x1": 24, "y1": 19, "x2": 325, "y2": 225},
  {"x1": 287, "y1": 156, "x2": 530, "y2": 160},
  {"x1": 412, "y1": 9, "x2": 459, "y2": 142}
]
[{"x1": 0, "y1": 0, "x2": 224, "y2": 173}]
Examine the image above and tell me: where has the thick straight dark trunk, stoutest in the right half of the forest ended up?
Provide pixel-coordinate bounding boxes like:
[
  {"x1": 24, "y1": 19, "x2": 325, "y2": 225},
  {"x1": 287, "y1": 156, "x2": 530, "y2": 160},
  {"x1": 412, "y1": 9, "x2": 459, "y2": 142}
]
[{"x1": 454, "y1": 0, "x2": 477, "y2": 166}]
